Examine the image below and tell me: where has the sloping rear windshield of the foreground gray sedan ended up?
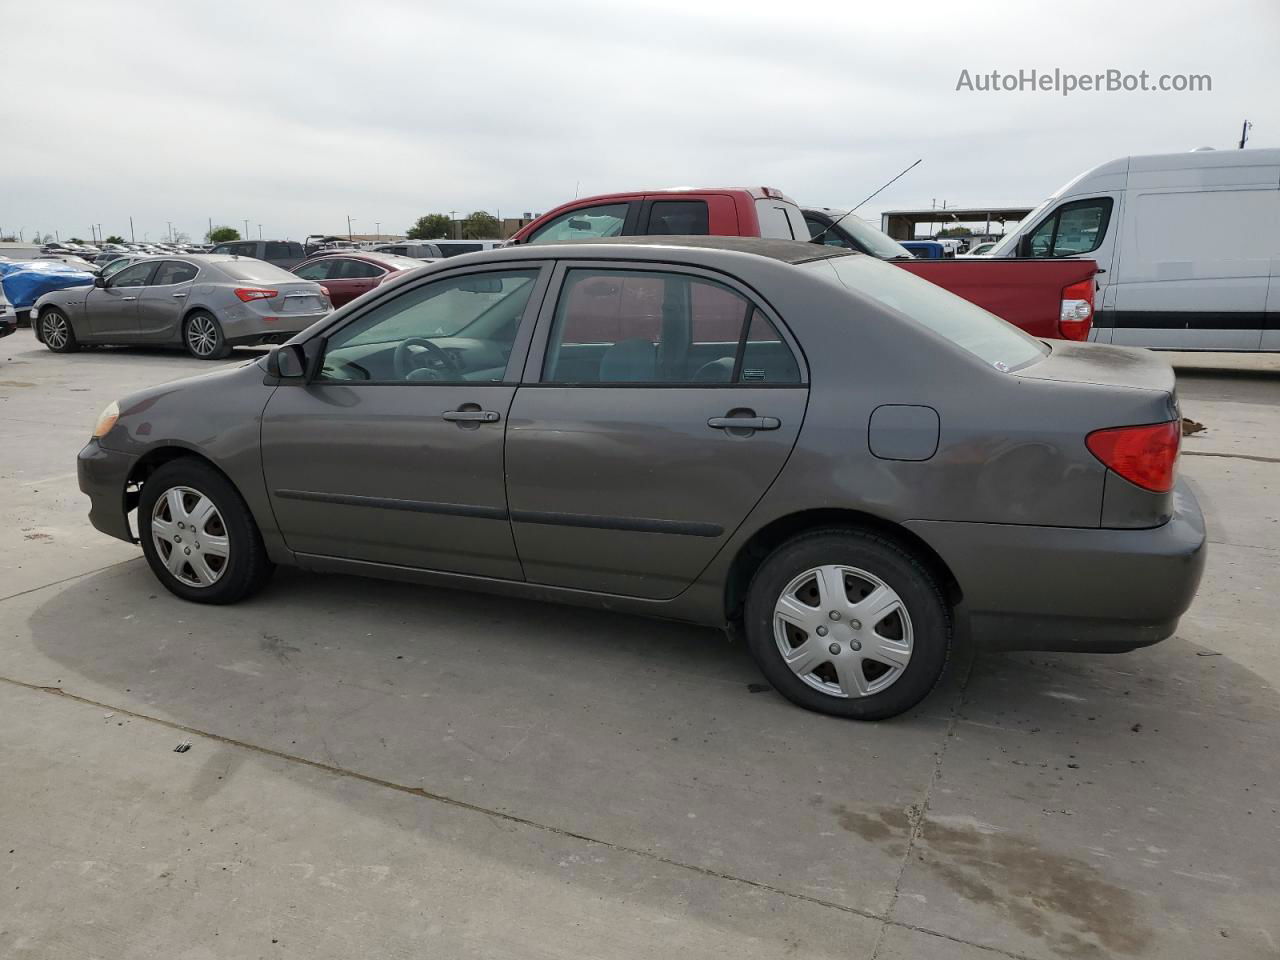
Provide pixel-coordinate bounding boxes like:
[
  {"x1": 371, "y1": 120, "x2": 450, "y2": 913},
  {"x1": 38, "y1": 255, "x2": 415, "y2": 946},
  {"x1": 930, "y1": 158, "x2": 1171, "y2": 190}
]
[{"x1": 804, "y1": 256, "x2": 1048, "y2": 371}]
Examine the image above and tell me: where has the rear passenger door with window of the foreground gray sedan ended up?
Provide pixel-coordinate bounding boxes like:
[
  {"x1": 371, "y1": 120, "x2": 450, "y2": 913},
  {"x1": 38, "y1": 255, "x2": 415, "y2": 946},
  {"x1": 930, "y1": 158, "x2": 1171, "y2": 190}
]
[{"x1": 507, "y1": 264, "x2": 808, "y2": 599}]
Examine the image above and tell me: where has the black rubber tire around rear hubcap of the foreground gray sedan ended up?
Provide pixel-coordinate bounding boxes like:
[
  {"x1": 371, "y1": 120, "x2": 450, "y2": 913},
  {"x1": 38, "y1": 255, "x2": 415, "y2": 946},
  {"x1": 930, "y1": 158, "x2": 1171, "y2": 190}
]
[{"x1": 744, "y1": 529, "x2": 952, "y2": 721}]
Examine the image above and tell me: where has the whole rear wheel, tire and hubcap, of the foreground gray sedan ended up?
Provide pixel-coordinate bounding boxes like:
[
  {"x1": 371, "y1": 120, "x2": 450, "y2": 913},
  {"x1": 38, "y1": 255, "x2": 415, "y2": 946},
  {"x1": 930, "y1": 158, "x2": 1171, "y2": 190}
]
[{"x1": 745, "y1": 530, "x2": 951, "y2": 719}]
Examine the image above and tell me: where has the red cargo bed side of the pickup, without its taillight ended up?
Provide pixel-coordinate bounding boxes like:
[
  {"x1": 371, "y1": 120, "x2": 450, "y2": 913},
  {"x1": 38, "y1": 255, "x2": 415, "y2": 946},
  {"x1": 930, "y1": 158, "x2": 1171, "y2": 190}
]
[{"x1": 892, "y1": 257, "x2": 1098, "y2": 339}]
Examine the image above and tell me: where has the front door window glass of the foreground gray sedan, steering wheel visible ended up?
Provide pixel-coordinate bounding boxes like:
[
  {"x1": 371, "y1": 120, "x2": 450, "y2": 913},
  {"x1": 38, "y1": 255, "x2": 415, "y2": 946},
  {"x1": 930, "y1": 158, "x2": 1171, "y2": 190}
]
[{"x1": 320, "y1": 270, "x2": 538, "y2": 384}]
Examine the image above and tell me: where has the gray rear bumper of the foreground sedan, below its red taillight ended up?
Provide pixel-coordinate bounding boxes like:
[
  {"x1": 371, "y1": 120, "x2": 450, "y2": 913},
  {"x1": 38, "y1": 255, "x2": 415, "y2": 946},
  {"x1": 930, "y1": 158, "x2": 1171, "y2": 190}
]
[{"x1": 906, "y1": 481, "x2": 1206, "y2": 653}]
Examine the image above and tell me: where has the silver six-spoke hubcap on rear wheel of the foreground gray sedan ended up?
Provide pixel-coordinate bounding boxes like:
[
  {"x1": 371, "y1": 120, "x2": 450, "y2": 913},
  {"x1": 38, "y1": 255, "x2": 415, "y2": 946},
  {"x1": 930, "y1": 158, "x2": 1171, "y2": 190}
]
[{"x1": 773, "y1": 564, "x2": 911, "y2": 698}]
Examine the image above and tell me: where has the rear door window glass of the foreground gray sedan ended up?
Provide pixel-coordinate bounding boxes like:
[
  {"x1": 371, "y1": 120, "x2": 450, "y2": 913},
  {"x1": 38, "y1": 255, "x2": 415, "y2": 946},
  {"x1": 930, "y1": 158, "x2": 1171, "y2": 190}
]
[{"x1": 543, "y1": 269, "x2": 800, "y2": 385}]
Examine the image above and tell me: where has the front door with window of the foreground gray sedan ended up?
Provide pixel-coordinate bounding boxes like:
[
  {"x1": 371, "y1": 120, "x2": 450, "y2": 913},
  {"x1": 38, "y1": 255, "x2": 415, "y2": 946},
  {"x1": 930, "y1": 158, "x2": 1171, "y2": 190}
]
[{"x1": 262, "y1": 264, "x2": 544, "y2": 580}]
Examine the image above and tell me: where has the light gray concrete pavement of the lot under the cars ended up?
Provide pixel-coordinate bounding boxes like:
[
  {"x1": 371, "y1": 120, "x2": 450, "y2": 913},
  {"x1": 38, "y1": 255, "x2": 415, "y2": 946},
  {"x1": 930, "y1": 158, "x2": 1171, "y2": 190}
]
[{"x1": 0, "y1": 330, "x2": 1280, "y2": 960}]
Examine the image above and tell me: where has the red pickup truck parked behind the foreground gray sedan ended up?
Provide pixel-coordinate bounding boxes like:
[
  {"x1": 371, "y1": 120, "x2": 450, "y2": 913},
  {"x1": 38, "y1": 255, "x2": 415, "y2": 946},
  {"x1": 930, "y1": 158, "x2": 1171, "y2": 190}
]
[{"x1": 511, "y1": 187, "x2": 1097, "y2": 340}]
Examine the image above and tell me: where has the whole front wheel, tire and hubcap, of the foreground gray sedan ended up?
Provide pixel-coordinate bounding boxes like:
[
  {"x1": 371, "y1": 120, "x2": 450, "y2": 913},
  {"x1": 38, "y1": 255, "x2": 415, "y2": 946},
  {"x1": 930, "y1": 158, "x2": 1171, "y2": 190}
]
[{"x1": 138, "y1": 460, "x2": 274, "y2": 604}]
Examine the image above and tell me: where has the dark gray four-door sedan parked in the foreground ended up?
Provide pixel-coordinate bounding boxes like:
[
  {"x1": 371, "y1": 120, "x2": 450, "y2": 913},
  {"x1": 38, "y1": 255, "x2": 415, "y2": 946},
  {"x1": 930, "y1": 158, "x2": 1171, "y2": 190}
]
[{"x1": 79, "y1": 237, "x2": 1206, "y2": 719}]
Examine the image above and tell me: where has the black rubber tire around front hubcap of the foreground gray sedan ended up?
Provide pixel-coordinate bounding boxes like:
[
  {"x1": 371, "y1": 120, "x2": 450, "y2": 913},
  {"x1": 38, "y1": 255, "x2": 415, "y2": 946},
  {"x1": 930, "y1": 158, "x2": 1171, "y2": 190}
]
[{"x1": 138, "y1": 458, "x2": 275, "y2": 604}]
